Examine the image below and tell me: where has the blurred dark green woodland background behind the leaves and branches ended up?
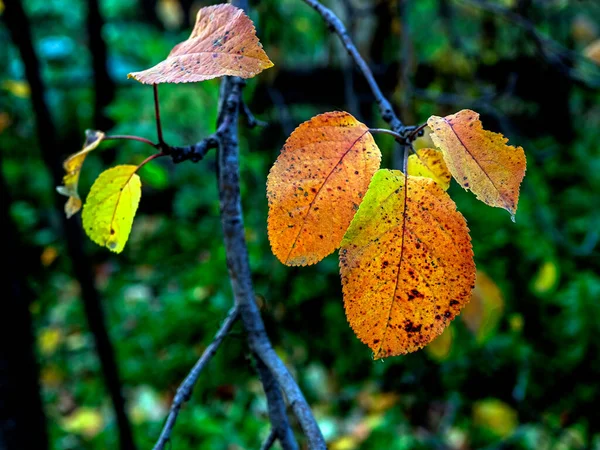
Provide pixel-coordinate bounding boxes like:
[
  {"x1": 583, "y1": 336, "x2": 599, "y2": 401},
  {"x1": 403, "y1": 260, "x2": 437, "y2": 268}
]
[{"x1": 0, "y1": 0, "x2": 600, "y2": 450}]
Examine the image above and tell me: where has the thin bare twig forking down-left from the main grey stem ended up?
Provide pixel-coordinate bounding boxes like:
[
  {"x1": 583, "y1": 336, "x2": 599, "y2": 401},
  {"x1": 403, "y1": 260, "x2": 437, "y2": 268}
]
[{"x1": 154, "y1": 306, "x2": 239, "y2": 450}]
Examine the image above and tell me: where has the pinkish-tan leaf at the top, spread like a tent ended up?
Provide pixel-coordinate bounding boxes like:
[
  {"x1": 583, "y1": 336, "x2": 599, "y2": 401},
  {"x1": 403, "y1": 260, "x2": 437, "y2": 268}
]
[{"x1": 128, "y1": 4, "x2": 273, "y2": 84}]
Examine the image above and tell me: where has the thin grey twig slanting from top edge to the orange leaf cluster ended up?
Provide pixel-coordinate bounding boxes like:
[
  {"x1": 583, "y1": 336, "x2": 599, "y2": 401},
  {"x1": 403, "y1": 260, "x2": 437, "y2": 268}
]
[{"x1": 304, "y1": 0, "x2": 406, "y2": 134}]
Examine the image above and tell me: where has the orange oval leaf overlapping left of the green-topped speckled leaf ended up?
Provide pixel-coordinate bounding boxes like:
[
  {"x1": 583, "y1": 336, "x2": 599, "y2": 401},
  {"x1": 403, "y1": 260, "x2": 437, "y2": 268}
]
[{"x1": 267, "y1": 112, "x2": 381, "y2": 266}]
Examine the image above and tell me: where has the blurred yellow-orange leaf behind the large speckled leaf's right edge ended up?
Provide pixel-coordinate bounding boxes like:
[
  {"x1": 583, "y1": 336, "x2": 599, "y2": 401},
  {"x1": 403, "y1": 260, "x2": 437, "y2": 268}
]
[{"x1": 461, "y1": 271, "x2": 504, "y2": 343}]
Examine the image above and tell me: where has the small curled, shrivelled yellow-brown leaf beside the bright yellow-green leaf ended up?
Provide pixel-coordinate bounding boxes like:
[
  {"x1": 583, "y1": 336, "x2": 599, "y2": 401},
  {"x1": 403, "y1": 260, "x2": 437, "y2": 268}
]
[{"x1": 56, "y1": 130, "x2": 104, "y2": 218}]
